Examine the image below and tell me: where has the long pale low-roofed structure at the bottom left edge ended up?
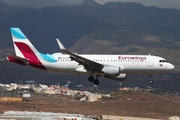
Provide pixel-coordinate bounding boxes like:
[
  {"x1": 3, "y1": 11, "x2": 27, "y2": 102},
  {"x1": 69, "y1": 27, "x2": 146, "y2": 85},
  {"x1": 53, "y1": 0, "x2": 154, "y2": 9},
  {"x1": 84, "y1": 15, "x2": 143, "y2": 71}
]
[{"x1": 0, "y1": 111, "x2": 93, "y2": 120}]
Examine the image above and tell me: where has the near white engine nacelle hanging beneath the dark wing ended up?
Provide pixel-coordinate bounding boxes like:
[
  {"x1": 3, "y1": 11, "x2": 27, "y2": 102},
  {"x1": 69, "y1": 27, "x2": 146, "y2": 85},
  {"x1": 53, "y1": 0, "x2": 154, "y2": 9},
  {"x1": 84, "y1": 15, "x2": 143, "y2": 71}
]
[{"x1": 102, "y1": 66, "x2": 120, "y2": 76}]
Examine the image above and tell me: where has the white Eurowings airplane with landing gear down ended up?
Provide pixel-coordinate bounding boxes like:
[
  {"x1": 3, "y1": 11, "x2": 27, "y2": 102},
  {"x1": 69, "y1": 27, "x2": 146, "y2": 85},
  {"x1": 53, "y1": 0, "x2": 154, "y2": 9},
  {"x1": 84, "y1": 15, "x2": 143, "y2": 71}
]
[{"x1": 7, "y1": 28, "x2": 175, "y2": 85}]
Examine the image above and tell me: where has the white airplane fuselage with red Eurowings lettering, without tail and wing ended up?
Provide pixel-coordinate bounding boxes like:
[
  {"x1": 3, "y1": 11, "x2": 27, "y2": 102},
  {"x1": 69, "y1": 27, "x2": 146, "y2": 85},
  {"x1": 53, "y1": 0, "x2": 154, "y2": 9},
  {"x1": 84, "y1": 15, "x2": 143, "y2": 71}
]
[{"x1": 41, "y1": 53, "x2": 174, "y2": 74}]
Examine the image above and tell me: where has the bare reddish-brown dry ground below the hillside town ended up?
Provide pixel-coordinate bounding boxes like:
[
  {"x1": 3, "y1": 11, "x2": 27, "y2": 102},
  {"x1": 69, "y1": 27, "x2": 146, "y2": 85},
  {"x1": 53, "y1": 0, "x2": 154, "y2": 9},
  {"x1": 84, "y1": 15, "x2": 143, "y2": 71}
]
[{"x1": 0, "y1": 92, "x2": 180, "y2": 118}]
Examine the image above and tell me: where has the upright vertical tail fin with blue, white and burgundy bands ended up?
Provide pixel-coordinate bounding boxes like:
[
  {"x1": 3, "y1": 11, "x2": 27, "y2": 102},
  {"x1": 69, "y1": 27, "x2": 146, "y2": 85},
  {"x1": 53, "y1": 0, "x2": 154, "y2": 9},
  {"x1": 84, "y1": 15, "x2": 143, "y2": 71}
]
[{"x1": 10, "y1": 28, "x2": 38, "y2": 59}]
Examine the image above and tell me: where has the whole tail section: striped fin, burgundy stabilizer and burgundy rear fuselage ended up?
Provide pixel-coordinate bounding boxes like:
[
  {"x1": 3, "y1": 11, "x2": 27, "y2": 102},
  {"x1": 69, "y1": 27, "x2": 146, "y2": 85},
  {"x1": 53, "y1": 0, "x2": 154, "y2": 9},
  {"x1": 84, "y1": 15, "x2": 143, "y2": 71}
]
[{"x1": 7, "y1": 28, "x2": 46, "y2": 70}]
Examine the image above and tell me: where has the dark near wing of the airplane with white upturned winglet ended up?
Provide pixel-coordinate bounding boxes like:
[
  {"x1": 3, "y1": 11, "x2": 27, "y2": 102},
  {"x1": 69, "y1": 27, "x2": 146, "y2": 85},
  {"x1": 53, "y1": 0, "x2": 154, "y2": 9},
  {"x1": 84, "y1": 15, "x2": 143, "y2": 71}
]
[{"x1": 56, "y1": 39, "x2": 104, "y2": 71}]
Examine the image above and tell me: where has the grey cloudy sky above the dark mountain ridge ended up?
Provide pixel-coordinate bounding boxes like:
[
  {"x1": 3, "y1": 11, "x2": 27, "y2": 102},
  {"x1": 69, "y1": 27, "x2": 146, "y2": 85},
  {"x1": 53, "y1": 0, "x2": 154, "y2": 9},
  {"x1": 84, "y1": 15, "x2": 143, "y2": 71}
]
[{"x1": 0, "y1": 0, "x2": 180, "y2": 10}]
